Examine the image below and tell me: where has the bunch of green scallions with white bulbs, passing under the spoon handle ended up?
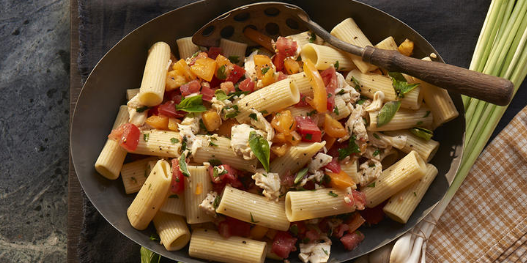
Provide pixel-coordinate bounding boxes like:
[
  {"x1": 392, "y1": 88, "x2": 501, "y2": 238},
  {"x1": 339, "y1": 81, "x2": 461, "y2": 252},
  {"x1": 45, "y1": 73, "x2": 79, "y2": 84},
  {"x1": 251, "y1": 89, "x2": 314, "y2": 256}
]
[{"x1": 357, "y1": 0, "x2": 527, "y2": 263}]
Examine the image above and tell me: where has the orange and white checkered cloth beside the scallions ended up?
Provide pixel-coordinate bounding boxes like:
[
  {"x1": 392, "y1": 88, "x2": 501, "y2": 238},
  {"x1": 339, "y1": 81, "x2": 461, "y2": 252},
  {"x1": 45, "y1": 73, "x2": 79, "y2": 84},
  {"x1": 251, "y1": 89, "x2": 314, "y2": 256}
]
[{"x1": 426, "y1": 107, "x2": 527, "y2": 262}]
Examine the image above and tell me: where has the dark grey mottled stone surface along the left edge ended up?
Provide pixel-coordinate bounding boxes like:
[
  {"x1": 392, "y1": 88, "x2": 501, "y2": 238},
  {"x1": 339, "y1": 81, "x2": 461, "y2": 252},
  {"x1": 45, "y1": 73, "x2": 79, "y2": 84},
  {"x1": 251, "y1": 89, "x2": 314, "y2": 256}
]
[{"x1": 0, "y1": 0, "x2": 70, "y2": 262}]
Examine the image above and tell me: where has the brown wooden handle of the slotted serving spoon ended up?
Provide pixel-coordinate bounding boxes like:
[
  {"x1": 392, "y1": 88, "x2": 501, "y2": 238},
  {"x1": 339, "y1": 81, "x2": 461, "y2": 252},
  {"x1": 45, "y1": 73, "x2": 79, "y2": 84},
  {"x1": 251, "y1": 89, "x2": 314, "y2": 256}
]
[{"x1": 362, "y1": 47, "x2": 514, "y2": 106}]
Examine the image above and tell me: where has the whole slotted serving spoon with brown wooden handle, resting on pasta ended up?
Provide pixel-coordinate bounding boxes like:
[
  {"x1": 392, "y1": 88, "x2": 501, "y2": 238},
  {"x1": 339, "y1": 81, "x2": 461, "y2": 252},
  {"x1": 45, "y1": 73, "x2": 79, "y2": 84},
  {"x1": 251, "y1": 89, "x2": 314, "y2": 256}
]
[{"x1": 192, "y1": 2, "x2": 514, "y2": 106}]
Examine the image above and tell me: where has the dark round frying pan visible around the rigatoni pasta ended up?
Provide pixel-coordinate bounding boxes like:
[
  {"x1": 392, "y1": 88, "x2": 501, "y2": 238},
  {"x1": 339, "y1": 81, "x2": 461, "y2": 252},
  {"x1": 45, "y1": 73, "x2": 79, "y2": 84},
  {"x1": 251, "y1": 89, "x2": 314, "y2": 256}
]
[{"x1": 70, "y1": 0, "x2": 465, "y2": 262}]
